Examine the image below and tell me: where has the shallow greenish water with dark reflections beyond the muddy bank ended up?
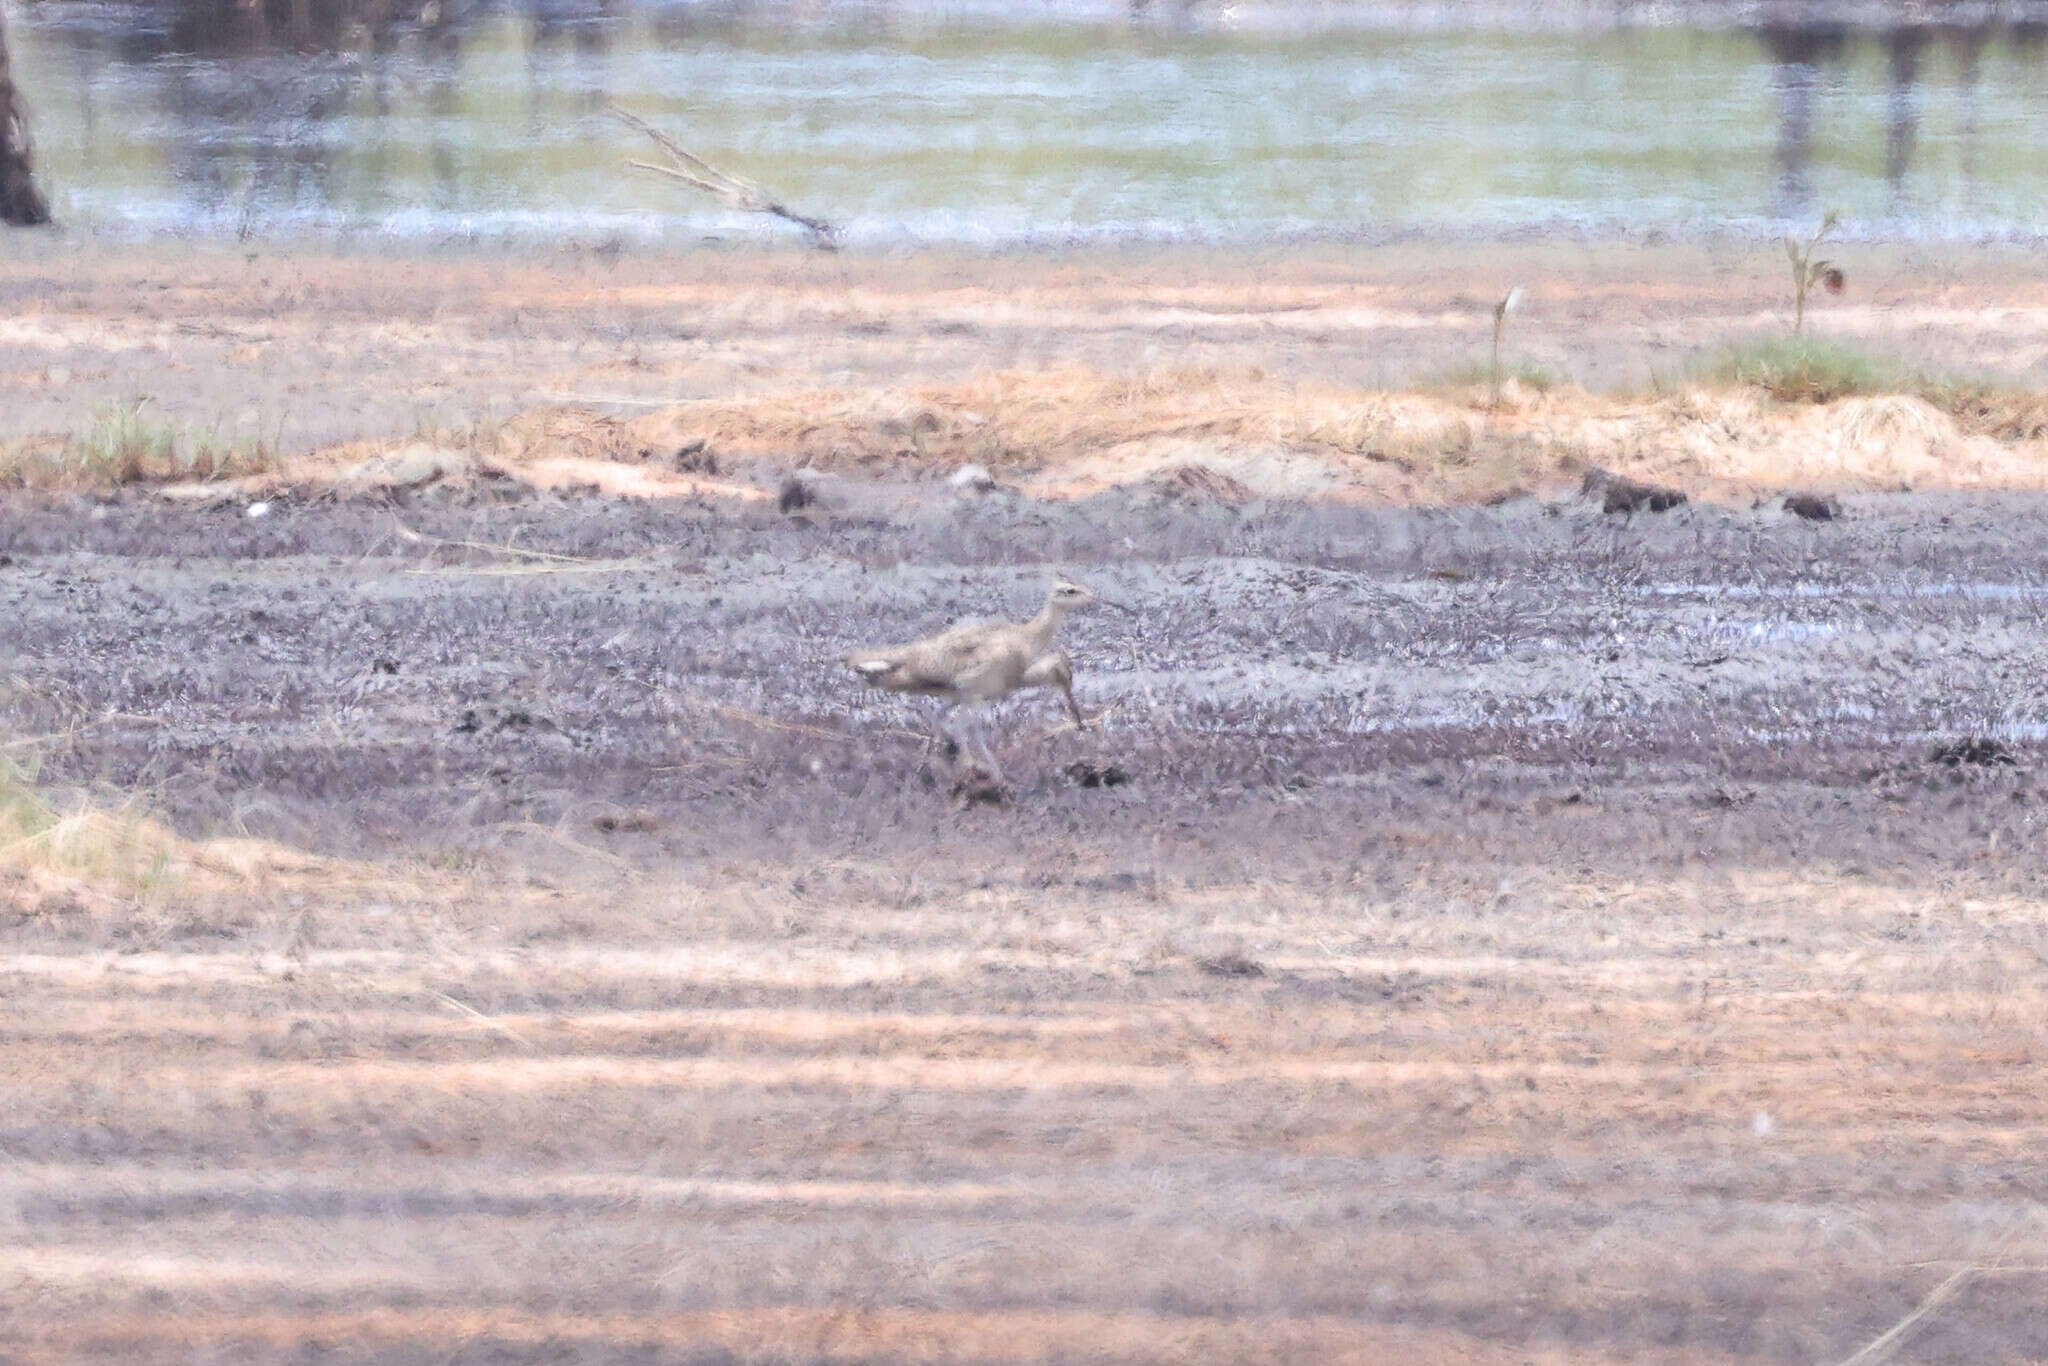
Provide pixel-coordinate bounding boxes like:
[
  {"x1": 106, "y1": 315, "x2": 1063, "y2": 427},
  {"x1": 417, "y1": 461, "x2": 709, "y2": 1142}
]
[{"x1": 14, "y1": 0, "x2": 2048, "y2": 244}]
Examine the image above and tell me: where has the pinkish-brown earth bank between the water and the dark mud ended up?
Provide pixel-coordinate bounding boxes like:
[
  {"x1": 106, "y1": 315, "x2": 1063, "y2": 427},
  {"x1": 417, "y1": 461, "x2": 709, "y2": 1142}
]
[{"x1": 0, "y1": 238, "x2": 2048, "y2": 504}]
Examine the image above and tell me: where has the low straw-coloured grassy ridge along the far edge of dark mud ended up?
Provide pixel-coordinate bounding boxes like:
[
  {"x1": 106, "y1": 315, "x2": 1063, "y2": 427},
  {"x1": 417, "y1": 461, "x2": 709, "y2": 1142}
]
[{"x1": 0, "y1": 338, "x2": 2048, "y2": 504}]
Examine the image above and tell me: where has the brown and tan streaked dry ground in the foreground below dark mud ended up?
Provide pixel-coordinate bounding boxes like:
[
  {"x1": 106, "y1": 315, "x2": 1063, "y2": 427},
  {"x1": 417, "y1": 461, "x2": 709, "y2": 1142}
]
[{"x1": 0, "y1": 850, "x2": 2044, "y2": 1366}]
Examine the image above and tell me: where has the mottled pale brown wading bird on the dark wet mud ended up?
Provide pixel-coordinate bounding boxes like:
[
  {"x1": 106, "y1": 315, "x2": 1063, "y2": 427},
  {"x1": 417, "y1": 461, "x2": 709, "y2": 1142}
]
[{"x1": 842, "y1": 575, "x2": 1128, "y2": 782}]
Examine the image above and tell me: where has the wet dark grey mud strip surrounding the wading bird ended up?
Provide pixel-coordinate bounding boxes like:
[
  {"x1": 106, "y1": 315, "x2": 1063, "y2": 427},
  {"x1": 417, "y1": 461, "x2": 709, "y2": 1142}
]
[{"x1": 0, "y1": 487, "x2": 2048, "y2": 888}]
